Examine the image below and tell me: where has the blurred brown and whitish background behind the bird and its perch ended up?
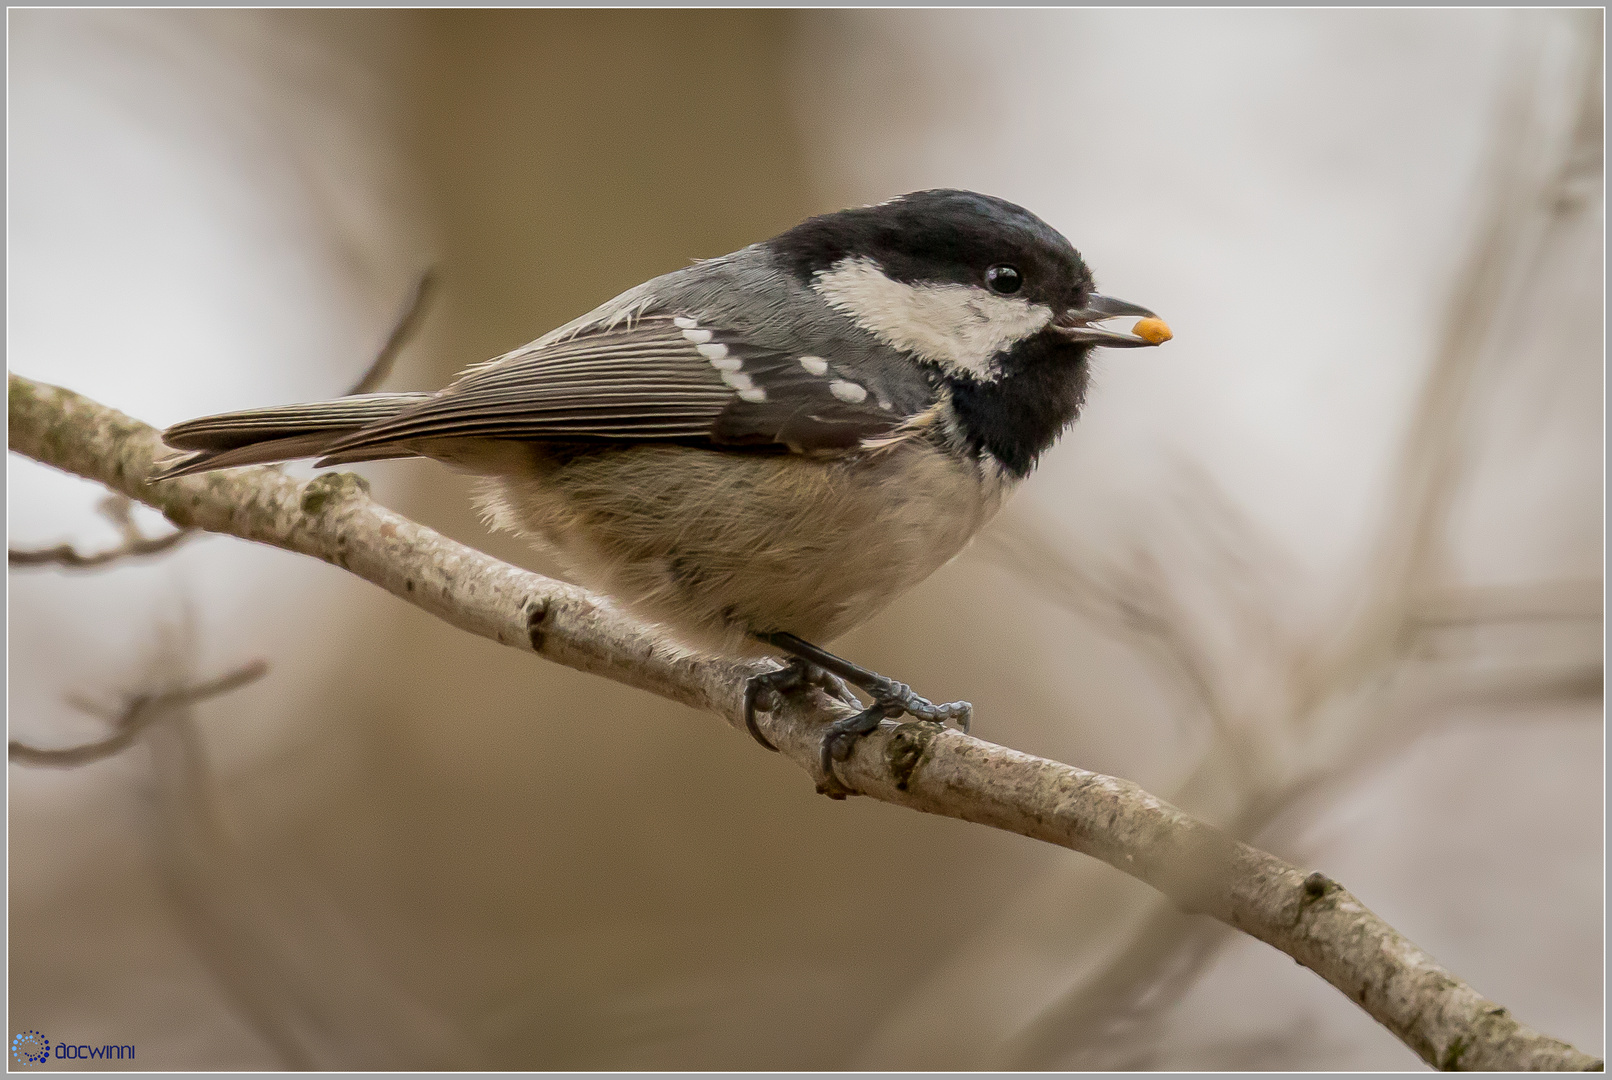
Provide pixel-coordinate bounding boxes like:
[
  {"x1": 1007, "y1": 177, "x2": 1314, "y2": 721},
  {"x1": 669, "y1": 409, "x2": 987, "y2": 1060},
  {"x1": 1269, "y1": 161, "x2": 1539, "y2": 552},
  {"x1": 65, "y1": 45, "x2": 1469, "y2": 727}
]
[{"x1": 6, "y1": 10, "x2": 1604, "y2": 1069}]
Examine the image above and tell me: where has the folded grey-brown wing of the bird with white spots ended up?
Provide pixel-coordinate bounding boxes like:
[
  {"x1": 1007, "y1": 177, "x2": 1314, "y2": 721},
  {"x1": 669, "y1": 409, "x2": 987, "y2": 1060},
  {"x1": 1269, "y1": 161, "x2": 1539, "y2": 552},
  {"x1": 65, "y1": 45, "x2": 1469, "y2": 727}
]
[{"x1": 326, "y1": 313, "x2": 909, "y2": 463}]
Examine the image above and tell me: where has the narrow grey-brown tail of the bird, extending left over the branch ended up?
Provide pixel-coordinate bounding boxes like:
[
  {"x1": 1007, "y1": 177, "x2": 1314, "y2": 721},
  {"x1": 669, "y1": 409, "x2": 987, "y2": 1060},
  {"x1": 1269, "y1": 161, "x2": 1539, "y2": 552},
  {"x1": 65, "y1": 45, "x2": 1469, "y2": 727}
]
[{"x1": 152, "y1": 393, "x2": 432, "y2": 480}]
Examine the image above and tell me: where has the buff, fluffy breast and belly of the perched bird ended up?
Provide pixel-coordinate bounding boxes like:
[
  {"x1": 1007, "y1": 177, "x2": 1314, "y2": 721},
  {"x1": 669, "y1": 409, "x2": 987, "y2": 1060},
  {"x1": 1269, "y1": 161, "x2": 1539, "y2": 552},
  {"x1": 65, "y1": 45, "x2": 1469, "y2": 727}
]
[{"x1": 482, "y1": 440, "x2": 1014, "y2": 654}]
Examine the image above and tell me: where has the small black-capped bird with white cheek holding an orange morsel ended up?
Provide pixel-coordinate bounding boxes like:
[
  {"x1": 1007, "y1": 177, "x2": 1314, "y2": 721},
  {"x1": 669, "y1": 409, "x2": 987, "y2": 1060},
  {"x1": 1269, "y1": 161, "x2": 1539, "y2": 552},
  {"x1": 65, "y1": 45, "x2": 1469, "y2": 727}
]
[{"x1": 153, "y1": 189, "x2": 1172, "y2": 793}]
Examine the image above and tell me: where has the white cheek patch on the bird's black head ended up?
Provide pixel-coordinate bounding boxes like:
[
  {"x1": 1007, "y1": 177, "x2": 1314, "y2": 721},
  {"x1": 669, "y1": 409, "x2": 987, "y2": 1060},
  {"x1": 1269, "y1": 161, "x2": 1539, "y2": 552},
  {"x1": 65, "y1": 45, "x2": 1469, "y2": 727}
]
[{"x1": 812, "y1": 258, "x2": 1053, "y2": 380}]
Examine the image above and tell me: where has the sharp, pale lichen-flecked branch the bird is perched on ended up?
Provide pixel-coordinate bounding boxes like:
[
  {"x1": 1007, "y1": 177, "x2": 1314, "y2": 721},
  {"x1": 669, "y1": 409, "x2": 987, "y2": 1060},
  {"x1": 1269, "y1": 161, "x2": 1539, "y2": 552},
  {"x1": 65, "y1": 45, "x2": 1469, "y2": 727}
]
[{"x1": 8, "y1": 374, "x2": 1602, "y2": 1070}]
